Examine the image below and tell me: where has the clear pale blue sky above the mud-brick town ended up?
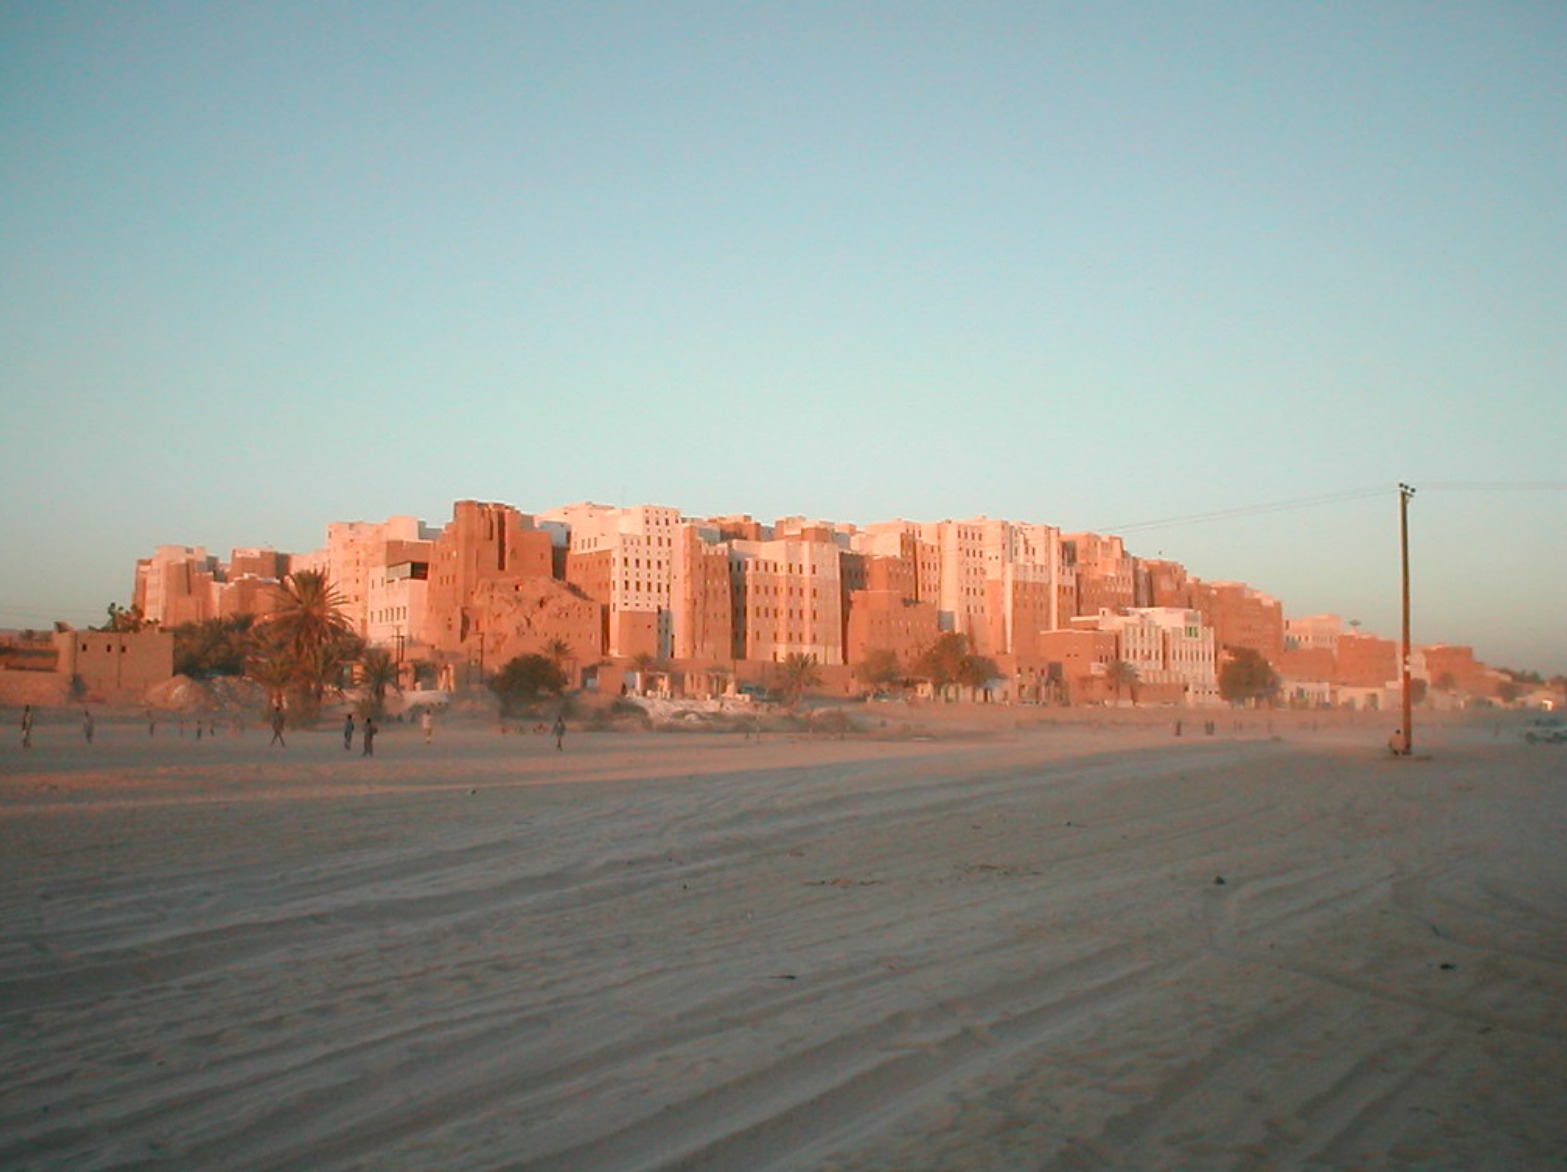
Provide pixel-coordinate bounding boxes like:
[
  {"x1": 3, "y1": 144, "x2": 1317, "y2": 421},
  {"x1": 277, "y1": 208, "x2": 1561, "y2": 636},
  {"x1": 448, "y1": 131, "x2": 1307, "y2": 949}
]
[{"x1": 0, "y1": 0, "x2": 1567, "y2": 674}]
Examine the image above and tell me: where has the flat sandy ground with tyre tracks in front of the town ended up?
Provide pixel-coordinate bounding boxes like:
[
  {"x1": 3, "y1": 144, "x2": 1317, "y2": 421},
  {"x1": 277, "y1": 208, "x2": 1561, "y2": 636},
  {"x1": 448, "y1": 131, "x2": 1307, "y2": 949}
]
[{"x1": 0, "y1": 713, "x2": 1567, "y2": 1172}]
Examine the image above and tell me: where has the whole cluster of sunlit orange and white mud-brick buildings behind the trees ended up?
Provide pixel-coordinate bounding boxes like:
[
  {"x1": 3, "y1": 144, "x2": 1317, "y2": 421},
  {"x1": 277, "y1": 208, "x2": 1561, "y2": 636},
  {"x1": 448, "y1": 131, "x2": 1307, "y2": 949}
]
[{"x1": 119, "y1": 491, "x2": 1501, "y2": 707}]
